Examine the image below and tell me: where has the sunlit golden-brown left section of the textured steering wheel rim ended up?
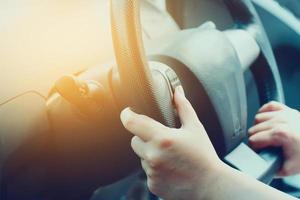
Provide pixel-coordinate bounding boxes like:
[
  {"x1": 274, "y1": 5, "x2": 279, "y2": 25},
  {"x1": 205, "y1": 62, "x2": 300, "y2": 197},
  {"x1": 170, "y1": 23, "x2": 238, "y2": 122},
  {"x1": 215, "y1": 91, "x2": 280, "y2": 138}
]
[{"x1": 111, "y1": 0, "x2": 174, "y2": 126}]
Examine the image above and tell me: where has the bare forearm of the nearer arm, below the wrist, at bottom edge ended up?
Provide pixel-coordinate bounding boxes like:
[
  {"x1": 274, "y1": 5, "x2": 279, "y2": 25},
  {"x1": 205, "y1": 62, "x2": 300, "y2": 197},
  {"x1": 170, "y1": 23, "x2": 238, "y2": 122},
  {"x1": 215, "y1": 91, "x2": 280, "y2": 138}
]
[{"x1": 198, "y1": 166, "x2": 295, "y2": 200}]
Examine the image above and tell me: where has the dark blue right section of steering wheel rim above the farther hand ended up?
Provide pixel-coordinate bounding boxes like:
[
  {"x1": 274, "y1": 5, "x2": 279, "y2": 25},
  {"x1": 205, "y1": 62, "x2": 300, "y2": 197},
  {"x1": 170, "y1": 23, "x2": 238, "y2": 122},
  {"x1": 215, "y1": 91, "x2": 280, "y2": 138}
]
[{"x1": 224, "y1": 0, "x2": 284, "y2": 104}]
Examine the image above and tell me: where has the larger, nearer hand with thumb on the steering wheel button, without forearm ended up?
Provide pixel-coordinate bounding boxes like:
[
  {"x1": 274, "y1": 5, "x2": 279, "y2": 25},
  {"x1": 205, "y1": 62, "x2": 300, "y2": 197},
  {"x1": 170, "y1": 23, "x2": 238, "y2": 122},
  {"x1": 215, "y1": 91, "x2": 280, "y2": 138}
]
[{"x1": 121, "y1": 87, "x2": 223, "y2": 200}]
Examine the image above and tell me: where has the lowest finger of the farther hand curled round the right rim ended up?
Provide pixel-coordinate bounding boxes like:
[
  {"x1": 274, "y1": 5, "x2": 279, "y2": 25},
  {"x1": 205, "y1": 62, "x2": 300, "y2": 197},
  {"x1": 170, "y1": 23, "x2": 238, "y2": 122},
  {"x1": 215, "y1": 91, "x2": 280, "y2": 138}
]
[{"x1": 249, "y1": 129, "x2": 281, "y2": 149}]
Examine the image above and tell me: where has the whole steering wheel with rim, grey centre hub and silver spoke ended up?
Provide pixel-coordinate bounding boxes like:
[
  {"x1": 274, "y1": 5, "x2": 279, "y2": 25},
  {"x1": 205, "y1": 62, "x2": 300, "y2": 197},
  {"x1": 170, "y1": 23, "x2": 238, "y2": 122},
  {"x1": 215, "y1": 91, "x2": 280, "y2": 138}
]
[{"x1": 111, "y1": 0, "x2": 284, "y2": 182}]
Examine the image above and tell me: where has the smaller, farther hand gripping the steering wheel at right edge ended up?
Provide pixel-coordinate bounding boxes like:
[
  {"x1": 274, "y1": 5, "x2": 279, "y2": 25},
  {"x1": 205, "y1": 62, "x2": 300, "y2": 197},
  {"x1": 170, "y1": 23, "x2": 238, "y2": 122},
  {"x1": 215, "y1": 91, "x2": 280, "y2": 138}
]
[{"x1": 249, "y1": 102, "x2": 300, "y2": 176}]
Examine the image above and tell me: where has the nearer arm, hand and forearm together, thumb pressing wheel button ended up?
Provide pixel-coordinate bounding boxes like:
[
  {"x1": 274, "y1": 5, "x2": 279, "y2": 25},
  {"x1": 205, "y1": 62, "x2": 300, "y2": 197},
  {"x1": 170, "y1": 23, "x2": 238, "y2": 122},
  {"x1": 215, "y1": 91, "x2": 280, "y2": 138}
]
[{"x1": 121, "y1": 87, "x2": 293, "y2": 200}]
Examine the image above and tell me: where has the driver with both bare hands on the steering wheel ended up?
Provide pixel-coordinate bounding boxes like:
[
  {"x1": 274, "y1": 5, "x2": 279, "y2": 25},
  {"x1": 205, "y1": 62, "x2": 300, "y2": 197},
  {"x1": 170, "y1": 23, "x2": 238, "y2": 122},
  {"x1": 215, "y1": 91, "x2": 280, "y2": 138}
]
[{"x1": 120, "y1": 86, "x2": 300, "y2": 200}]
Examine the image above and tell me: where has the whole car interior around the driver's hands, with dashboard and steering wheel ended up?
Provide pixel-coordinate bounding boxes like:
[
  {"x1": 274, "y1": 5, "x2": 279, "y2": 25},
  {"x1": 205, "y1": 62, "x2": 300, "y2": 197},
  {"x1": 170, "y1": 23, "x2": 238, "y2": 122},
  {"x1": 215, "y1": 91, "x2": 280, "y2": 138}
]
[{"x1": 0, "y1": 0, "x2": 300, "y2": 200}]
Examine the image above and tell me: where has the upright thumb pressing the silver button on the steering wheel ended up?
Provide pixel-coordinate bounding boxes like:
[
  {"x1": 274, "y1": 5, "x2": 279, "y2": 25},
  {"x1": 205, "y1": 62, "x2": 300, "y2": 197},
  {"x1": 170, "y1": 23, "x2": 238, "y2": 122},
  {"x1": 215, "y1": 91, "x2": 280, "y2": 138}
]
[{"x1": 174, "y1": 86, "x2": 200, "y2": 129}]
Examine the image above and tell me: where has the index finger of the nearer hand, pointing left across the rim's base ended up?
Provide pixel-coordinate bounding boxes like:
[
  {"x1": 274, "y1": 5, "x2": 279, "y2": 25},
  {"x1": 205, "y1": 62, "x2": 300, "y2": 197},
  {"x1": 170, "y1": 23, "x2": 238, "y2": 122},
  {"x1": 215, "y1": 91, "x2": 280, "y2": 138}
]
[{"x1": 120, "y1": 108, "x2": 168, "y2": 141}]
